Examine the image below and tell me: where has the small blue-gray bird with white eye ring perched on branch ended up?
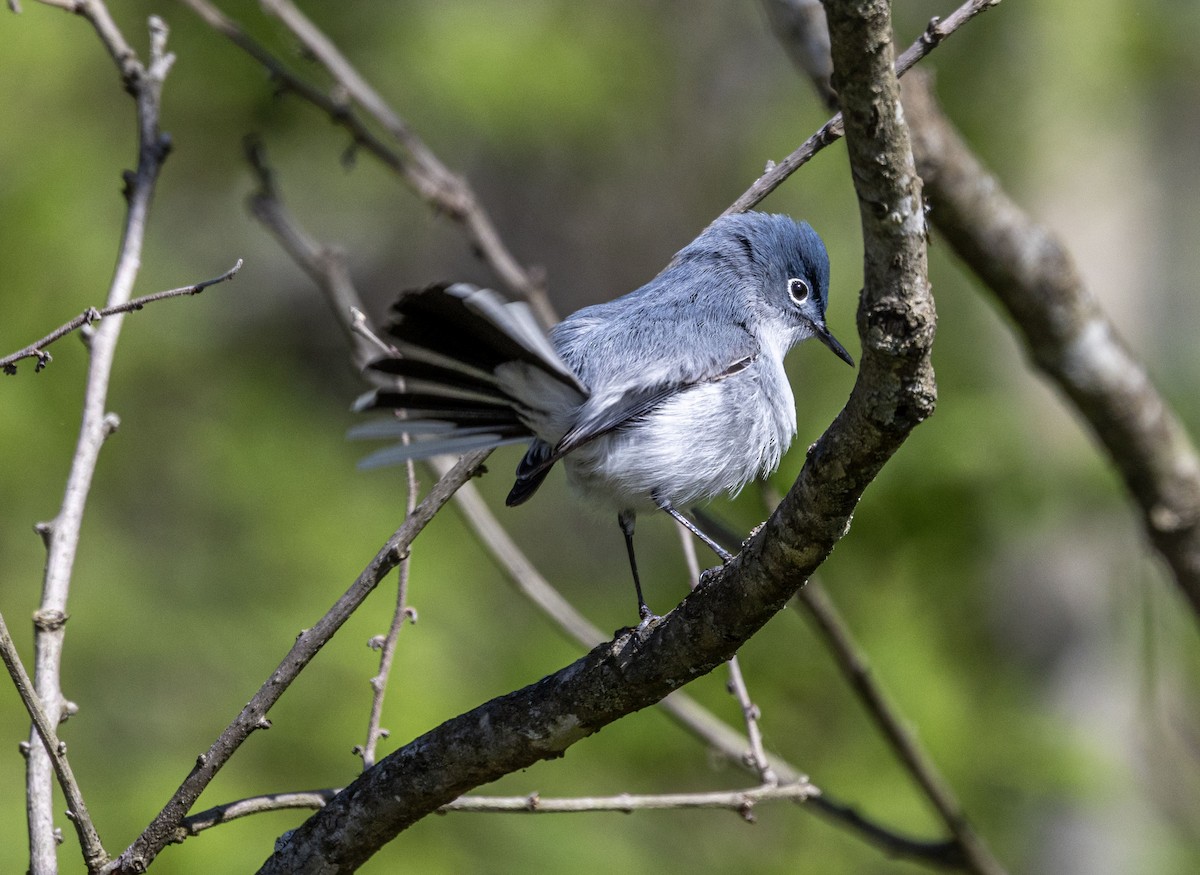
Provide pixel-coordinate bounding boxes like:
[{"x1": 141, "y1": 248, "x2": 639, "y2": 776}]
[{"x1": 352, "y1": 212, "x2": 854, "y2": 622}]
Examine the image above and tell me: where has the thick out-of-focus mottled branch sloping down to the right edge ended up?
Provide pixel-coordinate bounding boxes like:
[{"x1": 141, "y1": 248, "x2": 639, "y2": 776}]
[{"x1": 905, "y1": 80, "x2": 1200, "y2": 618}]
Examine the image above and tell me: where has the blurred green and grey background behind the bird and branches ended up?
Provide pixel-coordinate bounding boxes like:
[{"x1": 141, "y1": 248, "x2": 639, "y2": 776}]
[{"x1": 0, "y1": 0, "x2": 1200, "y2": 875}]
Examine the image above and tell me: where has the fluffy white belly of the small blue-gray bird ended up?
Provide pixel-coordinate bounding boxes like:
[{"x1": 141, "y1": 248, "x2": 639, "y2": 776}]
[{"x1": 563, "y1": 380, "x2": 796, "y2": 510}]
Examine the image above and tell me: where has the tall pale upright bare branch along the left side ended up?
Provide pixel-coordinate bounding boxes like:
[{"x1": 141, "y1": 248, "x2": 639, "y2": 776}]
[{"x1": 25, "y1": 8, "x2": 174, "y2": 875}]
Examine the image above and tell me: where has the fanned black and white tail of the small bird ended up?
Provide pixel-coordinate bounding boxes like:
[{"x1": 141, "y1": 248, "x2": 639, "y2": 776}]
[{"x1": 350, "y1": 283, "x2": 588, "y2": 470}]
